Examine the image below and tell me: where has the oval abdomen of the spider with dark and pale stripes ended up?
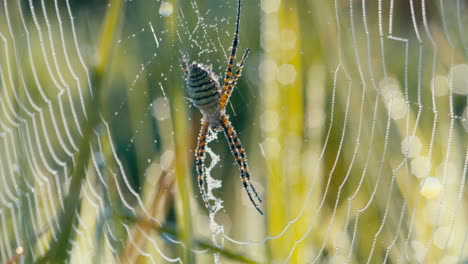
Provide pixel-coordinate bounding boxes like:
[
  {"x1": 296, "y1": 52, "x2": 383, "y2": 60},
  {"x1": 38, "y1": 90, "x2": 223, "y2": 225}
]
[{"x1": 187, "y1": 62, "x2": 220, "y2": 114}]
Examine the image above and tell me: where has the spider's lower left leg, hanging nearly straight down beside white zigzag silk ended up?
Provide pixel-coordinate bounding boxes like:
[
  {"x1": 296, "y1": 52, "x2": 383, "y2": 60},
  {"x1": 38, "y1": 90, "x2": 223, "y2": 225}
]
[{"x1": 195, "y1": 119, "x2": 213, "y2": 212}]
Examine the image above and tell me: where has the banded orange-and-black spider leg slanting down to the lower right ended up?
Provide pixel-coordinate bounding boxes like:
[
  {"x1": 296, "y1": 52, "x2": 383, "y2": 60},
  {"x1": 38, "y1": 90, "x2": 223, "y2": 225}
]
[{"x1": 221, "y1": 115, "x2": 263, "y2": 215}]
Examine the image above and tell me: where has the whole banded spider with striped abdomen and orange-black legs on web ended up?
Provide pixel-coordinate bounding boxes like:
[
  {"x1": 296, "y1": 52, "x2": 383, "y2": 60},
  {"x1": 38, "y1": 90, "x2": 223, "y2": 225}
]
[{"x1": 182, "y1": 0, "x2": 263, "y2": 215}]
